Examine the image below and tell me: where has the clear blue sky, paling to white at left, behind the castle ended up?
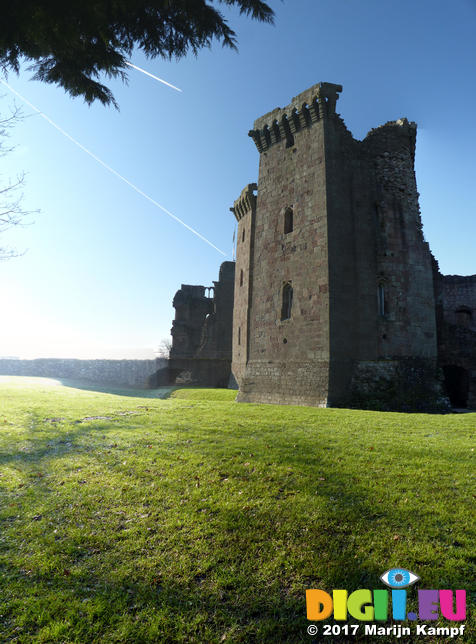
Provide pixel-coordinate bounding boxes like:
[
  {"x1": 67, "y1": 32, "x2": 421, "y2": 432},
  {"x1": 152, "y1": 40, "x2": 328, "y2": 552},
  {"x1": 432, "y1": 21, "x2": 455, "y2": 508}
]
[{"x1": 0, "y1": 0, "x2": 476, "y2": 358}]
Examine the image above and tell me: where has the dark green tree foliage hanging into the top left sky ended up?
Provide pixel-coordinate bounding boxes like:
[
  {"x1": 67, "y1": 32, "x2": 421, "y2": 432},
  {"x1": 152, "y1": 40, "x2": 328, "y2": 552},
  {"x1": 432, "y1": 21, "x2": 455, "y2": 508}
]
[{"x1": 0, "y1": 0, "x2": 273, "y2": 105}]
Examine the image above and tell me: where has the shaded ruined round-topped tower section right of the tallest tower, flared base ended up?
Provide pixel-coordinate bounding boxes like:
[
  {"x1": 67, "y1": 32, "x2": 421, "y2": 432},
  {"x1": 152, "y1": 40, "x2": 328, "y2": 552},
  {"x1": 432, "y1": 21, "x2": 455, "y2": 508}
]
[{"x1": 351, "y1": 119, "x2": 447, "y2": 411}]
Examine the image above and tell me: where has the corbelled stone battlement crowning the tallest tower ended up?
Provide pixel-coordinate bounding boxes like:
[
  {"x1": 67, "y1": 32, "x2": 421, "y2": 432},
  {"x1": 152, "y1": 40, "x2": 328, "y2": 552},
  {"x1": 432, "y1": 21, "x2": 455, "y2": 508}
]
[{"x1": 248, "y1": 83, "x2": 342, "y2": 152}]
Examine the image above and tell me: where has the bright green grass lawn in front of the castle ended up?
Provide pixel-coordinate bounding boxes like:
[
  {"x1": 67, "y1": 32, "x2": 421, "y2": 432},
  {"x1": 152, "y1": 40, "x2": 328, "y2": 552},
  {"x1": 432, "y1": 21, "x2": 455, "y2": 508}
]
[{"x1": 0, "y1": 378, "x2": 476, "y2": 644}]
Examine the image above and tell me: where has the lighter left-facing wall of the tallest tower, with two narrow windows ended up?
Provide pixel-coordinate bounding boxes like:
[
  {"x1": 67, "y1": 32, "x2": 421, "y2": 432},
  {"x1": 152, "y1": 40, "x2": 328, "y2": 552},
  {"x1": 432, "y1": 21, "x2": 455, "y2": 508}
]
[{"x1": 237, "y1": 85, "x2": 335, "y2": 405}]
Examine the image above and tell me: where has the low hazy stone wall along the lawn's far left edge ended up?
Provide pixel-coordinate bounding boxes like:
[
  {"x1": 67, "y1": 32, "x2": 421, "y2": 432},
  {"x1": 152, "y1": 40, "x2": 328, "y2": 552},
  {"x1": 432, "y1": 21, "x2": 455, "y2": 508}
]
[{"x1": 0, "y1": 358, "x2": 167, "y2": 387}]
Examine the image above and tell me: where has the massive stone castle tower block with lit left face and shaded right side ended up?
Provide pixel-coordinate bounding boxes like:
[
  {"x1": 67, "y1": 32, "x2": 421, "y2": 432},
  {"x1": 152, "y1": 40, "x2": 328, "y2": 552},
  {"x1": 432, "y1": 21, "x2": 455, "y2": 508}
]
[{"x1": 231, "y1": 83, "x2": 441, "y2": 406}]
